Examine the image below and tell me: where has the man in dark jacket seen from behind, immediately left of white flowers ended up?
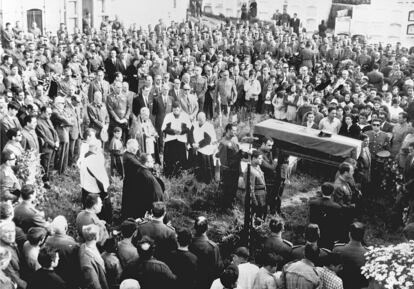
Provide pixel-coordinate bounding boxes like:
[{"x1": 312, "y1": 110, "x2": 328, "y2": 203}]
[{"x1": 333, "y1": 222, "x2": 368, "y2": 289}]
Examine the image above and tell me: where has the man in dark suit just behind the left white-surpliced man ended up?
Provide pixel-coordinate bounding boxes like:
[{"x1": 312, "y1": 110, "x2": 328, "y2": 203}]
[{"x1": 152, "y1": 84, "x2": 173, "y2": 151}]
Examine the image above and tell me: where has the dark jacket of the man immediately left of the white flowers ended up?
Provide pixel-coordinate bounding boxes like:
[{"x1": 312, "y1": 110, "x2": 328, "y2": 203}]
[{"x1": 332, "y1": 241, "x2": 368, "y2": 289}]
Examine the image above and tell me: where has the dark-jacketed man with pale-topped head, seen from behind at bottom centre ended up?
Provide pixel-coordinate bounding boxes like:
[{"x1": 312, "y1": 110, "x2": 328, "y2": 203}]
[{"x1": 189, "y1": 216, "x2": 223, "y2": 289}]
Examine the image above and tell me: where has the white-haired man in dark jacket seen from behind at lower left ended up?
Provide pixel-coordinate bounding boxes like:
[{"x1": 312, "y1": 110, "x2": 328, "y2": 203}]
[{"x1": 45, "y1": 216, "x2": 80, "y2": 288}]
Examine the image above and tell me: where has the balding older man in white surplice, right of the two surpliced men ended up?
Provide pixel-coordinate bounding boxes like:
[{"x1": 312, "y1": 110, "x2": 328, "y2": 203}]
[{"x1": 192, "y1": 112, "x2": 217, "y2": 184}]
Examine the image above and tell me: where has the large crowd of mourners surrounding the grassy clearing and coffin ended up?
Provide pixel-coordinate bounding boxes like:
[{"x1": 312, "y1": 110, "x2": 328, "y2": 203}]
[{"x1": 0, "y1": 5, "x2": 414, "y2": 289}]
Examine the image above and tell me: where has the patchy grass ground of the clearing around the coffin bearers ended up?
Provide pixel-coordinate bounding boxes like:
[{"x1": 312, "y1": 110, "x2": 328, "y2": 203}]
[{"x1": 43, "y1": 115, "x2": 402, "y2": 258}]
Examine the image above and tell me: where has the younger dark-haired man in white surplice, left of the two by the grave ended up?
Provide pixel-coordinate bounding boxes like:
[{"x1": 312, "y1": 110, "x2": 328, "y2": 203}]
[{"x1": 161, "y1": 102, "x2": 191, "y2": 177}]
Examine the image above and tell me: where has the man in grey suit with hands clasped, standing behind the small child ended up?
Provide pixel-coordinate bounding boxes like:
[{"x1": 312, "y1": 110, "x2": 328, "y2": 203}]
[{"x1": 107, "y1": 81, "x2": 132, "y2": 142}]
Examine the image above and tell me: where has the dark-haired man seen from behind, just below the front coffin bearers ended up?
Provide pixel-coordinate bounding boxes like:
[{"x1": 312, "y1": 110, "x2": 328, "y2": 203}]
[{"x1": 263, "y1": 218, "x2": 293, "y2": 266}]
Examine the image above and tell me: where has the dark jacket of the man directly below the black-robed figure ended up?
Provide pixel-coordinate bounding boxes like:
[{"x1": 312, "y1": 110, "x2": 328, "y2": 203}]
[{"x1": 132, "y1": 219, "x2": 177, "y2": 262}]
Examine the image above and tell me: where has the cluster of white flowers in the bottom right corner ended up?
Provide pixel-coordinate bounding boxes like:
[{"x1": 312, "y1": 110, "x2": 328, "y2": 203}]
[{"x1": 362, "y1": 241, "x2": 414, "y2": 289}]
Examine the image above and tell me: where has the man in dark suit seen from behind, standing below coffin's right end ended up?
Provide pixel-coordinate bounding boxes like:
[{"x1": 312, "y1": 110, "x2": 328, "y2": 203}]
[{"x1": 309, "y1": 183, "x2": 341, "y2": 249}]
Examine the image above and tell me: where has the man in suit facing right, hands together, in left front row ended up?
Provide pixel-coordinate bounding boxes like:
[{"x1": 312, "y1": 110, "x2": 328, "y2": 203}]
[{"x1": 36, "y1": 106, "x2": 59, "y2": 187}]
